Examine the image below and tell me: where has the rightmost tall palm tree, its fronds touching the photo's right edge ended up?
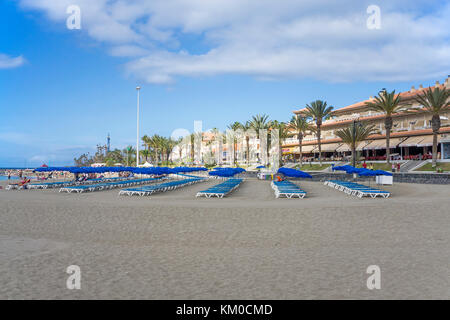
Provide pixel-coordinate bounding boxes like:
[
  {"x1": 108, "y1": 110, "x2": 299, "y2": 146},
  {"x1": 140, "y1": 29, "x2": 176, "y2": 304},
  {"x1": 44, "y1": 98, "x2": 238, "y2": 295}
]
[{"x1": 415, "y1": 87, "x2": 450, "y2": 168}]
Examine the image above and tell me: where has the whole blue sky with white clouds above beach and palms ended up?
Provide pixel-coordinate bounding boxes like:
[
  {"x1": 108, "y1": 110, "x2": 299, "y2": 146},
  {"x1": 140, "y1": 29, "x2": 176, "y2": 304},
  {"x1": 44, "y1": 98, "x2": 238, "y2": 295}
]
[{"x1": 0, "y1": 0, "x2": 450, "y2": 167}]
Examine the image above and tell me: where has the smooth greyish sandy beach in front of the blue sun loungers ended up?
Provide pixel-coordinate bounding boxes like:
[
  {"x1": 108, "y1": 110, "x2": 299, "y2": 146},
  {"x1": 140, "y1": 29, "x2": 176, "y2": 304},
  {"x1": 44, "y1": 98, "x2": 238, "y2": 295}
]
[{"x1": 0, "y1": 180, "x2": 450, "y2": 299}]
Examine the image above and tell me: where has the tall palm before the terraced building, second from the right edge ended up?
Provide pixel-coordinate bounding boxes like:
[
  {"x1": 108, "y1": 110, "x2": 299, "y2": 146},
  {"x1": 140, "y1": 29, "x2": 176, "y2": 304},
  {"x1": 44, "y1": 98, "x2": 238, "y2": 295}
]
[{"x1": 365, "y1": 89, "x2": 406, "y2": 164}]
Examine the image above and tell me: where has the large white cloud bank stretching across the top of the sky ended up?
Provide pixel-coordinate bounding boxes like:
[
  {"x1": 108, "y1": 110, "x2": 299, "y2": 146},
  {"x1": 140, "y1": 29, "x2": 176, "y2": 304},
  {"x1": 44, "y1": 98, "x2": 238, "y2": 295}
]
[{"x1": 16, "y1": 0, "x2": 450, "y2": 83}]
